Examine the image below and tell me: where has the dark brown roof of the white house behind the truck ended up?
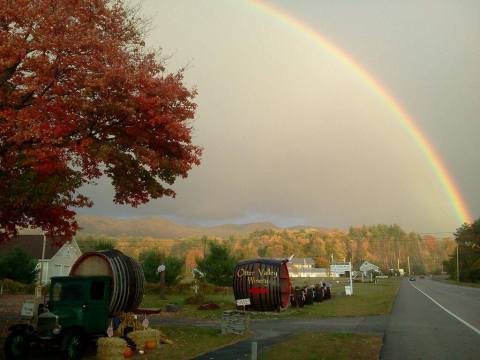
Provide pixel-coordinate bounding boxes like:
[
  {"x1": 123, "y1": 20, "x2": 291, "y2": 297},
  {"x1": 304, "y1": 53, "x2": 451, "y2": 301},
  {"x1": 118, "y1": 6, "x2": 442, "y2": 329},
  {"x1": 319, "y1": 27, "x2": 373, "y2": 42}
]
[{"x1": 0, "y1": 235, "x2": 65, "y2": 259}]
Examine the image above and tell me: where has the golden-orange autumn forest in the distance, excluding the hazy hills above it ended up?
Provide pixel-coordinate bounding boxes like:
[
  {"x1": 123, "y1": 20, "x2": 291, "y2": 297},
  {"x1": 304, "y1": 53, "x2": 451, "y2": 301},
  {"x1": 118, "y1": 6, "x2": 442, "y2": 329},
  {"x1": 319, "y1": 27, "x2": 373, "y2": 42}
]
[{"x1": 77, "y1": 225, "x2": 455, "y2": 274}]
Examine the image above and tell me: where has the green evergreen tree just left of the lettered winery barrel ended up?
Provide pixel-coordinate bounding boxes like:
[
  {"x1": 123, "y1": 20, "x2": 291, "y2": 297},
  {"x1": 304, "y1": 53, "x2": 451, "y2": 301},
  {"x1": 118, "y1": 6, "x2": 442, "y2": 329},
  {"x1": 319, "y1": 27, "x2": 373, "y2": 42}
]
[{"x1": 197, "y1": 242, "x2": 237, "y2": 286}]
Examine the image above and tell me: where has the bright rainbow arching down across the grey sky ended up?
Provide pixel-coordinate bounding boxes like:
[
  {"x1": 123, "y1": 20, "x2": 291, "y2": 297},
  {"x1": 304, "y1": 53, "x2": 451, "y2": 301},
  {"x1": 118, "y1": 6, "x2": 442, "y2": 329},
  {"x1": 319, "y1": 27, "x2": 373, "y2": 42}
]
[{"x1": 246, "y1": 0, "x2": 472, "y2": 223}]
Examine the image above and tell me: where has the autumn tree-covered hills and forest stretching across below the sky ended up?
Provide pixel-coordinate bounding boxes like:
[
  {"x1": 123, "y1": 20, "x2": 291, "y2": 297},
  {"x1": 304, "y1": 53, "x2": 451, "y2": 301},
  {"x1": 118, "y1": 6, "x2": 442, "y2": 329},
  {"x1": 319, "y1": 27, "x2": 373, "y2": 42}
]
[{"x1": 77, "y1": 218, "x2": 455, "y2": 273}]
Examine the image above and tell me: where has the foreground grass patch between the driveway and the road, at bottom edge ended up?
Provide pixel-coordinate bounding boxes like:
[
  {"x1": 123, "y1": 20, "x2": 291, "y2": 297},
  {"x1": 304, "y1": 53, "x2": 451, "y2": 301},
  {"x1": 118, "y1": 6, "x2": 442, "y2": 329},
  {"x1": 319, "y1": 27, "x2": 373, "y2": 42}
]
[{"x1": 258, "y1": 332, "x2": 382, "y2": 360}]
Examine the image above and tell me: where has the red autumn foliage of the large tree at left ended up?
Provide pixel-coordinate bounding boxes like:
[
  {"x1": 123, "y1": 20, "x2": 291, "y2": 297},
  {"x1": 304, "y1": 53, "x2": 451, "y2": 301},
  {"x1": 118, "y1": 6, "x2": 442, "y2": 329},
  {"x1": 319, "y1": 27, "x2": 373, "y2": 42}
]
[{"x1": 0, "y1": 0, "x2": 201, "y2": 241}]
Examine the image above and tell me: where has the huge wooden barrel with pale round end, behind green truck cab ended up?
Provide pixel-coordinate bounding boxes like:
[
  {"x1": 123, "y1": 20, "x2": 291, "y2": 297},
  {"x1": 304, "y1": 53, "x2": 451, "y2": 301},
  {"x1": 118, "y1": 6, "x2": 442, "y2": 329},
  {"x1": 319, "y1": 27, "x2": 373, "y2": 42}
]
[{"x1": 70, "y1": 250, "x2": 145, "y2": 313}]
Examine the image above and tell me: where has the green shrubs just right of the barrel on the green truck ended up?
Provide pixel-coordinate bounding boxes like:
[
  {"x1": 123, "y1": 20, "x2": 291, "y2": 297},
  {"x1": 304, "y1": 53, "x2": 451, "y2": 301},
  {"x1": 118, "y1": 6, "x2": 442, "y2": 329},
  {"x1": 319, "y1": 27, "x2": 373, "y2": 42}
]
[{"x1": 139, "y1": 249, "x2": 184, "y2": 285}]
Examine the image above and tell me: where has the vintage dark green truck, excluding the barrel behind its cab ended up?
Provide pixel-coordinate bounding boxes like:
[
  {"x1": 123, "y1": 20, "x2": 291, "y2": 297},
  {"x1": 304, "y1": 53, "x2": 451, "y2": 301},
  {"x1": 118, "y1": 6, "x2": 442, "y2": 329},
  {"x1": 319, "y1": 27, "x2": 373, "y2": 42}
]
[{"x1": 4, "y1": 276, "x2": 111, "y2": 360}]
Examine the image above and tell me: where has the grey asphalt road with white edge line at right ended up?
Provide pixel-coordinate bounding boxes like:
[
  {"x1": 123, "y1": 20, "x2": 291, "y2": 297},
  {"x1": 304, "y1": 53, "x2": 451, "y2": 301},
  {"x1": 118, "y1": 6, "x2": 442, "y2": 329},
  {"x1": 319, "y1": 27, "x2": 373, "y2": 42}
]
[{"x1": 381, "y1": 279, "x2": 480, "y2": 360}]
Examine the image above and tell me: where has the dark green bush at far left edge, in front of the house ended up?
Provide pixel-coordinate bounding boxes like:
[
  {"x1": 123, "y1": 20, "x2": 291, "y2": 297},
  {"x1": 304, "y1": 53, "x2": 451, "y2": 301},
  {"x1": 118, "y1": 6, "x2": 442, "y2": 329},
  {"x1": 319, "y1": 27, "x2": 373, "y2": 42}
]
[{"x1": 0, "y1": 247, "x2": 37, "y2": 284}]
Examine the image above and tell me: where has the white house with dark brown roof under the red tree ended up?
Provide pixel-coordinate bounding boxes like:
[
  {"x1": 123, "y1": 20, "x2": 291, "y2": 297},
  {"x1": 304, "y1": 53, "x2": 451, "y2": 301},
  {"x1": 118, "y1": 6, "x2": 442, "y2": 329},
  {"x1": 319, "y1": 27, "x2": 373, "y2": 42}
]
[{"x1": 0, "y1": 235, "x2": 82, "y2": 284}]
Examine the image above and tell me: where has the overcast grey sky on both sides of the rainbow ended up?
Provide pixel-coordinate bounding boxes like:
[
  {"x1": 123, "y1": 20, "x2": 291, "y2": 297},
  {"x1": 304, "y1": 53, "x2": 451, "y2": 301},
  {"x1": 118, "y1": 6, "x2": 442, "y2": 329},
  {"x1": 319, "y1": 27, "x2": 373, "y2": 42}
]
[{"x1": 80, "y1": 0, "x2": 480, "y2": 232}]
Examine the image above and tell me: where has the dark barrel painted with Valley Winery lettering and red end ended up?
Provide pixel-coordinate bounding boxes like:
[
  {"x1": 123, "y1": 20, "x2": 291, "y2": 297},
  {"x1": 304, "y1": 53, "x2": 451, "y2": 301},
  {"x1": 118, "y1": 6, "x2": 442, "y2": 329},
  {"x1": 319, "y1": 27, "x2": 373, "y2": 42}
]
[{"x1": 233, "y1": 259, "x2": 291, "y2": 311}]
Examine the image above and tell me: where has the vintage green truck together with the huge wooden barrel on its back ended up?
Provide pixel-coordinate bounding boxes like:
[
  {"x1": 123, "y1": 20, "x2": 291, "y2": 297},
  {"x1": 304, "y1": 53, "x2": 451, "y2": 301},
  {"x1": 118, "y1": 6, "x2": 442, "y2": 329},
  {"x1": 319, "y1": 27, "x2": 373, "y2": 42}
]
[{"x1": 4, "y1": 250, "x2": 144, "y2": 360}]
